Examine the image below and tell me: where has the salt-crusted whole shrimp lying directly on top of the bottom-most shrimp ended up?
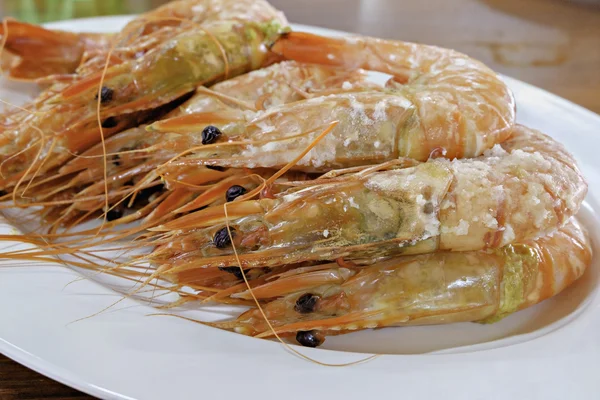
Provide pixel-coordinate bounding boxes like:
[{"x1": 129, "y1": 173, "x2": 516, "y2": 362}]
[{"x1": 150, "y1": 126, "x2": 587, "y2": 273}]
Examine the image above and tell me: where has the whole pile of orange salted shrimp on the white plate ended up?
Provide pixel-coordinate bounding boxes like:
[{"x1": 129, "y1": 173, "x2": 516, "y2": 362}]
[{"x1": 0, "y1": 0, "x2": 592, "y2": 347}]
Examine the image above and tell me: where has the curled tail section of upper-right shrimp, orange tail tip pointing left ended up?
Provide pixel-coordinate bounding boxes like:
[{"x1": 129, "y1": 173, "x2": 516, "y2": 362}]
[{"x1": 271, "y1": 32, "x2": 515, "y2": 160}]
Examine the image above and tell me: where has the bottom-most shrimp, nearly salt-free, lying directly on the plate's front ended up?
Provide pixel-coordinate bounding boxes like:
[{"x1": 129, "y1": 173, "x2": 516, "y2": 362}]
[{"x1": 212, "y1": 219, "x2": 592, "y2": 347}]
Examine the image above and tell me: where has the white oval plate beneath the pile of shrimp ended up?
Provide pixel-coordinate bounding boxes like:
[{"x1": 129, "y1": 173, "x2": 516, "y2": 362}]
[{"x1": 0, "y1": 17, "x2": 600, "y2": 400}]
